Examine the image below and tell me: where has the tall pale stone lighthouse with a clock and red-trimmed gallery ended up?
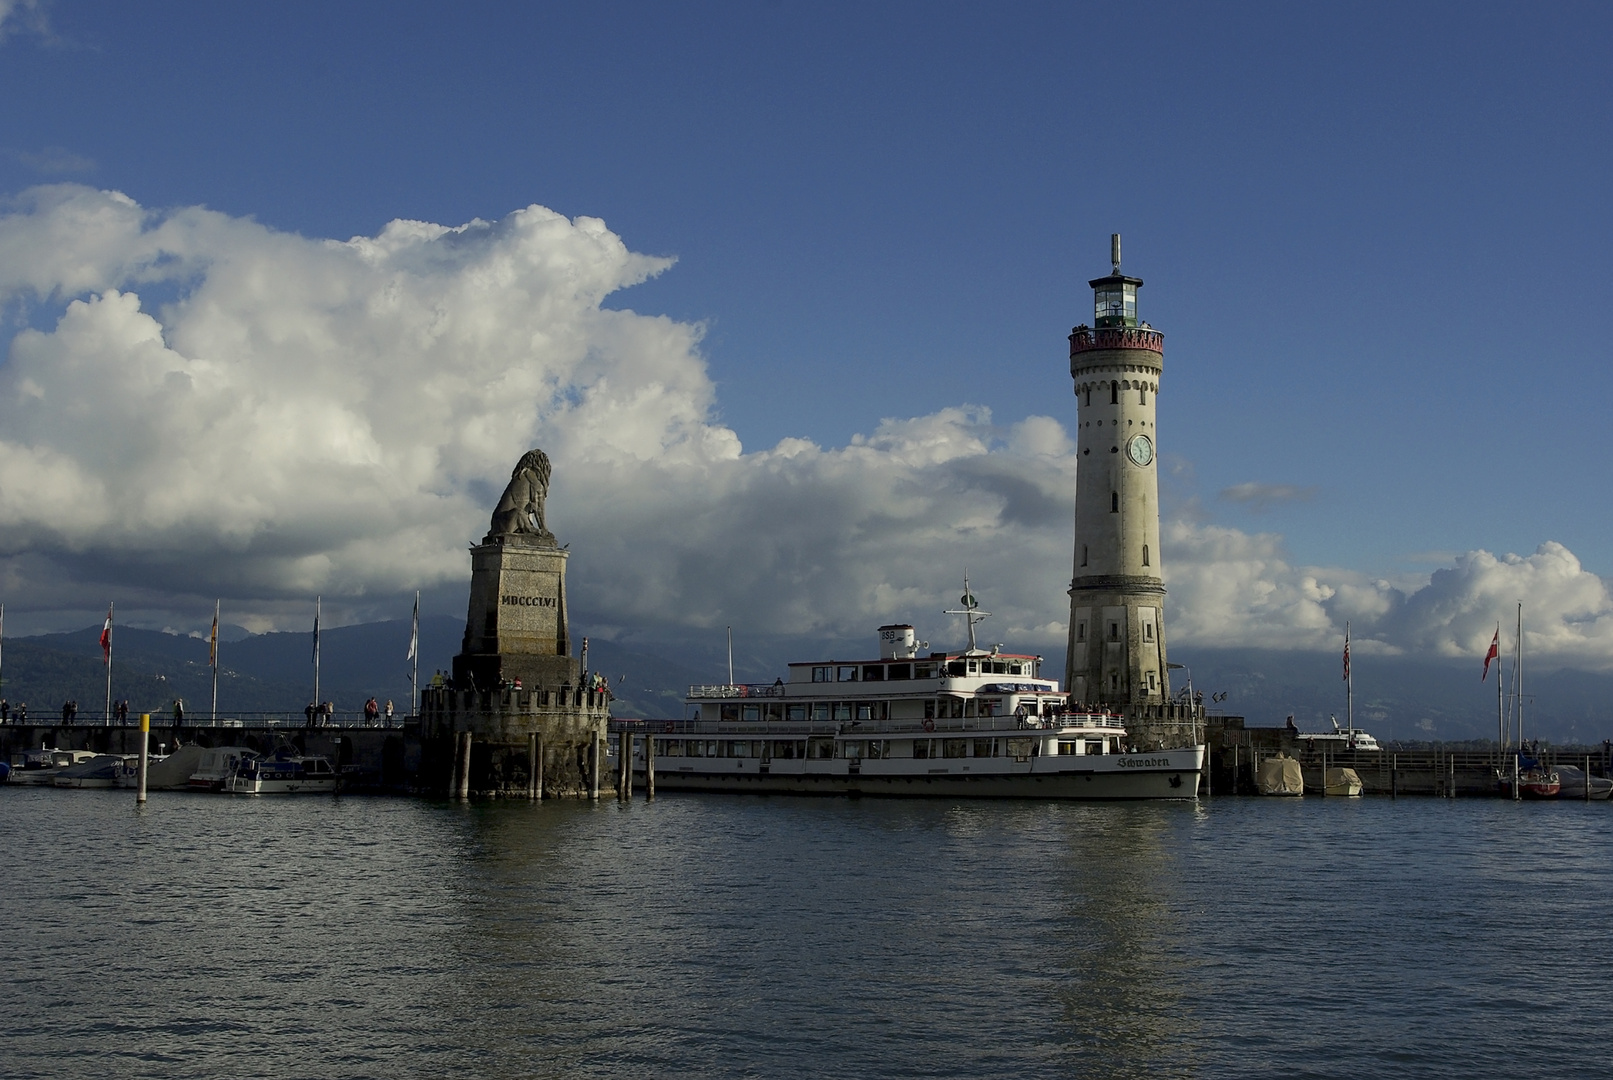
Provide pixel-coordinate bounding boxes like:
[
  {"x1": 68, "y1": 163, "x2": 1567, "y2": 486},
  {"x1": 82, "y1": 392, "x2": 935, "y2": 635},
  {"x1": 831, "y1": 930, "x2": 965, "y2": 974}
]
[{"x1": 1065, "y1": 234, "x2": 1197, "y2": 735}]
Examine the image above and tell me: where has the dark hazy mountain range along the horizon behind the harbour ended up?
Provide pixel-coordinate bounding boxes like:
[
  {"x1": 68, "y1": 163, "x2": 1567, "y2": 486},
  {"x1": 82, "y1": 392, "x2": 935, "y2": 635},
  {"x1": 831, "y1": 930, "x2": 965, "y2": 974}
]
[{"x1": 0, "y1": 616, "x2": 1613, "y2": 743}]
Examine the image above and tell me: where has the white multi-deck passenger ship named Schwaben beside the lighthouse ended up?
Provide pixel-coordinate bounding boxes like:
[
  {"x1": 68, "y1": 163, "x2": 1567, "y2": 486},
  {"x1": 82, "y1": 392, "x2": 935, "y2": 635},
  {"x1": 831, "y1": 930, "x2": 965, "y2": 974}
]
[{"x1": 634, "y1": 606, "x2": 1205, "y2": 800}]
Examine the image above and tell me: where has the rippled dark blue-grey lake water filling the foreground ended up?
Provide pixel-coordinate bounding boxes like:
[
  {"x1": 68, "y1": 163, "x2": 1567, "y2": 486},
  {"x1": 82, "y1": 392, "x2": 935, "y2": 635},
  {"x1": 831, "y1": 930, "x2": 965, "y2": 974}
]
[{"x1": 0, "y1": 788, "x2": 1613, "y2": 1080}]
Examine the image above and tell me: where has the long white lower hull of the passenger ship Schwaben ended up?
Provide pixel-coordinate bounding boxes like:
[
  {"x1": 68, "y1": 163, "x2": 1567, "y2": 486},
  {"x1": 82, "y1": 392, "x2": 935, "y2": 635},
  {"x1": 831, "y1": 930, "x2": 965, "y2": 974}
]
[{"x1": 636, "y1": 746, "x2": 1203, "y2": 800}]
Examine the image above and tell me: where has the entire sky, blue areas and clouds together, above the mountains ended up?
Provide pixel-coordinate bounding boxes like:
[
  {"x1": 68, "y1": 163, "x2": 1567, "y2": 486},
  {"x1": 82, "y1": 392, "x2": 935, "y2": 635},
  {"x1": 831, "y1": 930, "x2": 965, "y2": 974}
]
[{"x1": 0, "y1": 0, "x2": 1613, "y2": 671}]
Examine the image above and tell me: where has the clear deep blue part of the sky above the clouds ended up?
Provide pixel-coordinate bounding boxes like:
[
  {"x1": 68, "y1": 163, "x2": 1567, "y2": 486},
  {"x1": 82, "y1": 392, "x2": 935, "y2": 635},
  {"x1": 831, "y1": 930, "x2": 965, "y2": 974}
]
[{"x1": 0, "y1": 0, "x2": 1613, "y2": 673}]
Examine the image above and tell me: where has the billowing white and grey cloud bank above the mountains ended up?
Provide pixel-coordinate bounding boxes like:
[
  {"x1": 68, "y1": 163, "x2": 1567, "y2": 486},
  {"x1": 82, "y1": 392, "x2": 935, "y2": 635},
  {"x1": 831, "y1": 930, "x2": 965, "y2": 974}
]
[{"x1": 0, "y1": 184, "x2": 1613, "y2": 667}]
